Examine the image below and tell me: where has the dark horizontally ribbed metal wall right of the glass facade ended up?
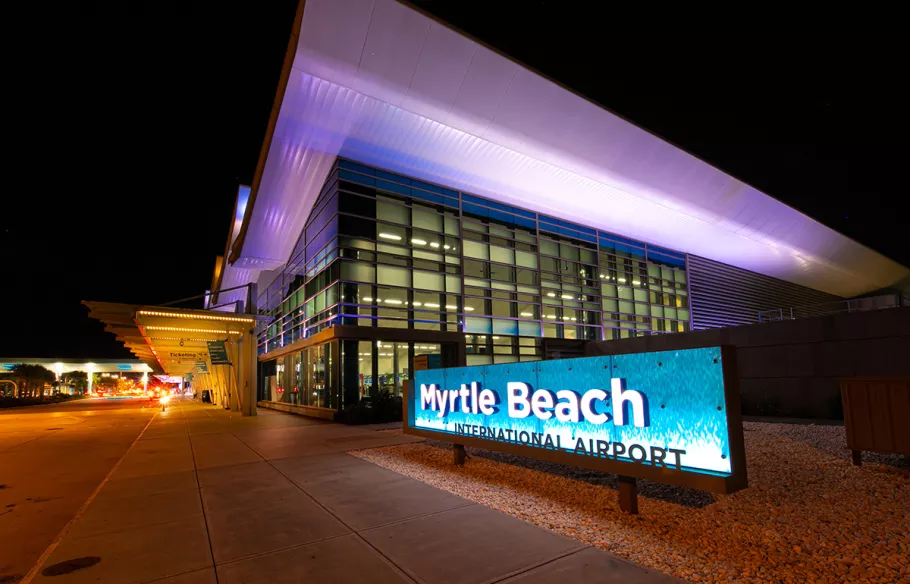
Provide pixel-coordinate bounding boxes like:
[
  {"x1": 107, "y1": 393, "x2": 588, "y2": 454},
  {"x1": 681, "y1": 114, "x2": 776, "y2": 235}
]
[{"x1": 688, "y1": 255, "x2": 842, "y2": 330}]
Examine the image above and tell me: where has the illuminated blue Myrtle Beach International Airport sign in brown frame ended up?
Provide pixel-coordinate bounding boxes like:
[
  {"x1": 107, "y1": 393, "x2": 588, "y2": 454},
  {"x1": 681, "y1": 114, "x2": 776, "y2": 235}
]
[{"x1": 406, "y1": 347, "x2": 745, "y2": 492}]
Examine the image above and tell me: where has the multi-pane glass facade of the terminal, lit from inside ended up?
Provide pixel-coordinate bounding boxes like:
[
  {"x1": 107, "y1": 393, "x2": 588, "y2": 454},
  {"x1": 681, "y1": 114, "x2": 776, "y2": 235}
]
[{"x1": 258, "y1": 160, "x2": 689, "y2": 408}]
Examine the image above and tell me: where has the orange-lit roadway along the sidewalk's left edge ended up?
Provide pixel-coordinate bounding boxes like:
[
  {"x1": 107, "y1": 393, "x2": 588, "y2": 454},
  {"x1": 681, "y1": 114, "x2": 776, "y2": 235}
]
[{"x1": 0, "y1": 399, "x2": 159, "y2": 584}]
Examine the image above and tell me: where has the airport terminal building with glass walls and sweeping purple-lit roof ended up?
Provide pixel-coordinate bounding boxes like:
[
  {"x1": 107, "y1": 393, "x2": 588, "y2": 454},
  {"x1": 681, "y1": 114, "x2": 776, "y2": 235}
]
[{"x1": 210, "y1": 0, "x2": 910, "y2": 416}]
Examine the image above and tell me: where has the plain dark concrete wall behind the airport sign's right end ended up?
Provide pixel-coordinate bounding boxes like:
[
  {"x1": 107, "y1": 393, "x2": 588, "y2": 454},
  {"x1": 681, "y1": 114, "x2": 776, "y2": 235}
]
[{"x1": 586, "y1": 307, "x2": 910, "y2": 419}]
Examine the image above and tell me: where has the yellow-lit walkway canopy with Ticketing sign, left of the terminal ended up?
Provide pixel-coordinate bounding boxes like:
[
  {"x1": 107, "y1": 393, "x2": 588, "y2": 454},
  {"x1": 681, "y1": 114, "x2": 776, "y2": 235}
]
[{"x1": 83, "y1": 301, "x2": 256, "y2": 415}]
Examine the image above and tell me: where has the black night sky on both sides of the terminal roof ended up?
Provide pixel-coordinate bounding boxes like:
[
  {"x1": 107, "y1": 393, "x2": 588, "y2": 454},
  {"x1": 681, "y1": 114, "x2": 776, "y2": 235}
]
[{"x1": 0, "y1": 1, "x2": 910, "y2": 358}]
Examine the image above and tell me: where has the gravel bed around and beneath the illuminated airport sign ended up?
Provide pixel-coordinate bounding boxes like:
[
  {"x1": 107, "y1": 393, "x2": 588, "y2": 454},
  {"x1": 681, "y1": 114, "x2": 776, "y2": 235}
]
[{"x1": 352, "y1": 422, "x2": 910, "y2": 584}]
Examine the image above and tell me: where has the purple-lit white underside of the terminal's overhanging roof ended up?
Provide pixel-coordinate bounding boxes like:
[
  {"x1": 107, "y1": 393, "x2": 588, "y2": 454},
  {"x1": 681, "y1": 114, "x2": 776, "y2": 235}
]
[{"x1": 234, "y1": 0, "x2": 910, "y2": 296}]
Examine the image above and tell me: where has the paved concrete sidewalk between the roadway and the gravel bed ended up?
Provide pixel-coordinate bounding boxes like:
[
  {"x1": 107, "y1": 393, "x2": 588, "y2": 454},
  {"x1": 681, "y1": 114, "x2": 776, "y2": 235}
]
[{"x1": 28, "y1": 401, "x2": 675, "y2": 584}]
